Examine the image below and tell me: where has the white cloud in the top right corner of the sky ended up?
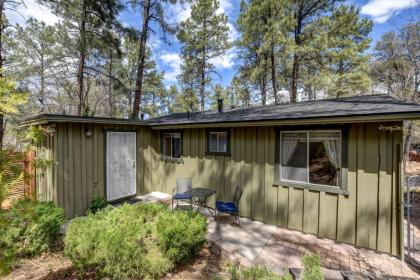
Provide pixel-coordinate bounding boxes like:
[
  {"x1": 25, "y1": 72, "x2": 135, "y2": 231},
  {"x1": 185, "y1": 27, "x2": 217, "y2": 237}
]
[{"x1": 361, "y1": 0, "x2": 420, "y2": 23}]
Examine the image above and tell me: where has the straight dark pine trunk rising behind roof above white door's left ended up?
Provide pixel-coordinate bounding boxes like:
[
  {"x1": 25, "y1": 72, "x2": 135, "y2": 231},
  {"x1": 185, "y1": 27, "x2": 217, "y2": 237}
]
[{"x1": 77, "y1": 0, "x2": 87, "y2": 115}]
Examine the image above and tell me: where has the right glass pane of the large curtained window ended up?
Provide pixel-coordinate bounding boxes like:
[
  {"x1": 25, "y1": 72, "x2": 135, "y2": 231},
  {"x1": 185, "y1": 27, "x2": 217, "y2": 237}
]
[{"x1": 309, "y1": 131, "x2": 341, "y2": 186}]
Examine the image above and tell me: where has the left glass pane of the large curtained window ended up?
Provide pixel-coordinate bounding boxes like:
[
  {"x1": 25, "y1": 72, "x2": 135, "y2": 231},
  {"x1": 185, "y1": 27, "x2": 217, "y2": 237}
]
[{"x1": 280, "y1": 132, "x2": 308, "y2": 183}]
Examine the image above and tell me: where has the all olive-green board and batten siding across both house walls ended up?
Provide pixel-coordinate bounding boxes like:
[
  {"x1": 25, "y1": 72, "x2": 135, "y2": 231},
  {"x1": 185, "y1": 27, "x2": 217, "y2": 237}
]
[{"x1": 37, "y1": 122, "x2": 402, "y2": 256}]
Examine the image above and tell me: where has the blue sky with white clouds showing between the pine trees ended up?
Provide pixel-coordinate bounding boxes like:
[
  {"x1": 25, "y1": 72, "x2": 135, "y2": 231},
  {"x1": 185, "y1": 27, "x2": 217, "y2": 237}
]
[{"x1": 7, "y1": 0, "x2": 420, "y2": 86}]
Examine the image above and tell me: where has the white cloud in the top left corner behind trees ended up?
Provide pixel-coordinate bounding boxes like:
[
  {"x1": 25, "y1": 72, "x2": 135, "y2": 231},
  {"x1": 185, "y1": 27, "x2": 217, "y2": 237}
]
[{"x1": 6, "y1": 0, "x2": 59, "y2": 25}]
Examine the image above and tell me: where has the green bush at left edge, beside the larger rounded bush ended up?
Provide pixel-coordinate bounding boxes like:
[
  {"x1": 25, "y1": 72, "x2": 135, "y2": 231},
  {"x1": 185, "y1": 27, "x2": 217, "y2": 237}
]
[{"x1": 0, "y1": 200, "x2": 64, "y2": 275}]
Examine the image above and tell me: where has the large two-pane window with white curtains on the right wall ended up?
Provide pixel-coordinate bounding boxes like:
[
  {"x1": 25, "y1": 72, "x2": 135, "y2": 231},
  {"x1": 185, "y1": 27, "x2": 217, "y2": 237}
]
[{"x1": 280, "y1": 130, "x2": 342, "y2": 188}]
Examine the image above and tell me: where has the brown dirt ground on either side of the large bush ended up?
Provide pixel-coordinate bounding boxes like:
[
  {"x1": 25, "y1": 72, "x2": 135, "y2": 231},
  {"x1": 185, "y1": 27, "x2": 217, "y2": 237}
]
[{"x1": 1, "y1": 248, "x2": 228, "y2": 280}]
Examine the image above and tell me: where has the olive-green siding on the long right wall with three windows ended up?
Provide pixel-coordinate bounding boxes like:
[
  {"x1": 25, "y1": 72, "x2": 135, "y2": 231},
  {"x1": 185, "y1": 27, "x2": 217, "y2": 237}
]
[{"x1": 141, "y1": 123, "x2": 402, "y2": 256}]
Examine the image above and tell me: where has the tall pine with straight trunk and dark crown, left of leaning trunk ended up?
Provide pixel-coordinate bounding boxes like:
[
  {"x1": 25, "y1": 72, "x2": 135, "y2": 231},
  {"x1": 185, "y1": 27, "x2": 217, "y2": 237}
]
[{"x1": 40, "y1": 0, "x2": 122, "y2": 114}]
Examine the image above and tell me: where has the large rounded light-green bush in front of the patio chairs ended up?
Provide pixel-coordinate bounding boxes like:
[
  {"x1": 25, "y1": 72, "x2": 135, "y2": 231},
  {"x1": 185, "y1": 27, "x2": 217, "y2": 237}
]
[{"x1": 64, "y1": 204, "x2": 206, "y2": 279}]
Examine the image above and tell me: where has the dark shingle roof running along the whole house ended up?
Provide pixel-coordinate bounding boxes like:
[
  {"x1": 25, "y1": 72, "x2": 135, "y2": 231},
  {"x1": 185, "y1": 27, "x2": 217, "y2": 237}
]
[{"x1": 20, "y1": 95, "x2": 420, "y2": 127}]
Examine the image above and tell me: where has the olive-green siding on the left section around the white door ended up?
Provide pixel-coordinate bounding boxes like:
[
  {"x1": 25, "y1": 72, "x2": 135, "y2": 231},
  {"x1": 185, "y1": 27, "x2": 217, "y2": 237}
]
[{"x1": 36, "y1": 123, "x2": 150, "y2": 218}]
